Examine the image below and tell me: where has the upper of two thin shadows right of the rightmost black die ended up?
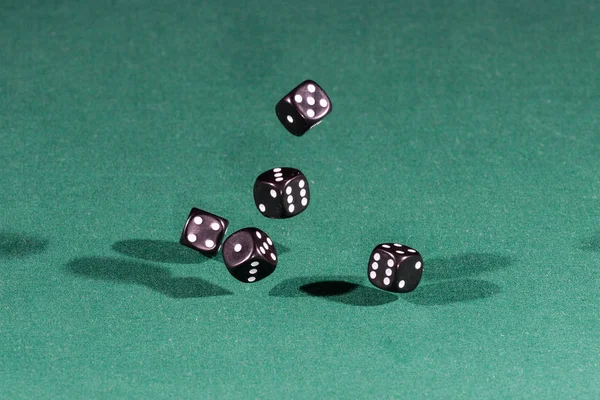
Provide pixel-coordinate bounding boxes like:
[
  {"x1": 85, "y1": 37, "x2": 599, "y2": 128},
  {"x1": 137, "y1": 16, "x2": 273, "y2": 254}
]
[{"x1": 424, "y1": 253, "x2": 515, "y2": 282}]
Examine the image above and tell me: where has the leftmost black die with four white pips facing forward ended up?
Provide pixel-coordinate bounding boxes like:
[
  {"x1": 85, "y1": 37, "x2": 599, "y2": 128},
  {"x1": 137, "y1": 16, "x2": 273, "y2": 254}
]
[{"x1": 179, "y1": 208, "x2": 229, "y2": 257}]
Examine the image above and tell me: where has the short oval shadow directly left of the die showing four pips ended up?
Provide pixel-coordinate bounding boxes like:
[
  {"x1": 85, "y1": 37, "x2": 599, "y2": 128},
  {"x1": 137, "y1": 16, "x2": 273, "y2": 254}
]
[{"x1": 111, "y1": 239, "x2": 209, "y2": 264}]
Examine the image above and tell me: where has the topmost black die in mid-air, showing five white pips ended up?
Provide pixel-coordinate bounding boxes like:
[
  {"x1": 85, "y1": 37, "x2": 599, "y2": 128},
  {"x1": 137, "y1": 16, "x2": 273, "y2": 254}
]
[{"x1": 275, "y1": 80, "x2": 331, "y2": 136}]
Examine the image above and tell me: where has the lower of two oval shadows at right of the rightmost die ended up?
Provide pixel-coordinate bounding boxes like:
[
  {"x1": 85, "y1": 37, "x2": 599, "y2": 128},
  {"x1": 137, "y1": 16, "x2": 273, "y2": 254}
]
[{"x1": 402, "y1": 278, "x2": 501, "y2": 306}]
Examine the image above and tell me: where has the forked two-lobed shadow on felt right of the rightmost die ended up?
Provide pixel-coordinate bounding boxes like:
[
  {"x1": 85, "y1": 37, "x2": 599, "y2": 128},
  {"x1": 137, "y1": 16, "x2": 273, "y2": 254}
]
[{"x1": 402, "y1": 253, "x2": 515, "y2": 306}]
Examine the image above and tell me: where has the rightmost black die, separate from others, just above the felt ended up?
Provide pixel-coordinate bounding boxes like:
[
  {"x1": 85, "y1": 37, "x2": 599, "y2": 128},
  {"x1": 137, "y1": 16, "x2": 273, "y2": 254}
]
[{"x1": 368, "y1": 243, "x2": 423, "y2": 292}]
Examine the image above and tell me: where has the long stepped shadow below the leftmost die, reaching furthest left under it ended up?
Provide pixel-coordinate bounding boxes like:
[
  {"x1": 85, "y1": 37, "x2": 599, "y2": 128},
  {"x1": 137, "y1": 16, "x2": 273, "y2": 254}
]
[{"x1": 66, "y1": 257, "x2": 233, "y2": 299}]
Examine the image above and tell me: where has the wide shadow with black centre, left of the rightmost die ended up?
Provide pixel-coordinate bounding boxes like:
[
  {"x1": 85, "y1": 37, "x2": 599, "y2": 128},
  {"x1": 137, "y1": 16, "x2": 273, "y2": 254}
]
[{"x1": 269, "y1": 276, "x2": 398, "y2": 307}]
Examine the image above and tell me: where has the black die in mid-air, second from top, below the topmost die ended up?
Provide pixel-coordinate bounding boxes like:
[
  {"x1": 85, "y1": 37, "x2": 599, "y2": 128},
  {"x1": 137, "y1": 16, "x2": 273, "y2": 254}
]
[{"x1": 254, "y1": 168, "x2": 310, "y2": 218}]
